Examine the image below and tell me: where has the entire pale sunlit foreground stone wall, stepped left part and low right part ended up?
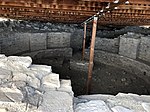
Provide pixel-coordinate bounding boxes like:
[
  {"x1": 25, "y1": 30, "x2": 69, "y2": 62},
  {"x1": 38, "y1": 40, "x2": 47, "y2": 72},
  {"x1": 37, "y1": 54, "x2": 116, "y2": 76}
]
[{"x1": 0, "y1": 54, "x2": 150, "y2": 112}]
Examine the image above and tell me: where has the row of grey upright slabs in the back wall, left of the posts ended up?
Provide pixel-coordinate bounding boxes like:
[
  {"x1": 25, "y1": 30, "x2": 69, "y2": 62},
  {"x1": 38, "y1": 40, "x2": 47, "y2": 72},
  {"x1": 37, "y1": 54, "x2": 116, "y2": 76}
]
[{"x1": 1, "y1": 32, "x2": 71, "y2": 55}]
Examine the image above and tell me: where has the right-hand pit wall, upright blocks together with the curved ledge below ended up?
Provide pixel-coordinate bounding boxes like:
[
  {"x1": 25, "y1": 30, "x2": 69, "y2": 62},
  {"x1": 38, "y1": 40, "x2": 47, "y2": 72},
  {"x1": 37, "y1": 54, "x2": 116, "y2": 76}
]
[{"x1": 86, "y1": 32, "x2": 150, "y2": 84}]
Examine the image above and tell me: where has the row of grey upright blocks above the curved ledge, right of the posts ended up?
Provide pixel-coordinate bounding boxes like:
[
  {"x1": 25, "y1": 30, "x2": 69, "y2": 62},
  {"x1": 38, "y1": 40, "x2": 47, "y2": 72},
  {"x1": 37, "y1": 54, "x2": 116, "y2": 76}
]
[{"x1": 95, "y1": 32, "x2": 150, "y2": 62}]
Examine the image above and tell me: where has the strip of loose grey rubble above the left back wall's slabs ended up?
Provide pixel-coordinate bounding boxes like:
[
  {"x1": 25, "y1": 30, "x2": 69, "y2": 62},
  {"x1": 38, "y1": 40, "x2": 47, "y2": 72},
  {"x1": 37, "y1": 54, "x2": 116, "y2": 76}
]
[{"x1": 0, "y1": 19, "x2": 78, "y2": 32}]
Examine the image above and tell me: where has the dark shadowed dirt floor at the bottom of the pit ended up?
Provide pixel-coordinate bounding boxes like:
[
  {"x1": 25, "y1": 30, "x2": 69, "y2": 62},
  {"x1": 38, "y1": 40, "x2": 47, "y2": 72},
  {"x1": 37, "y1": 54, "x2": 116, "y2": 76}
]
[{"x1": 35, "y1": 53, "x2": 150, "y2": 96}]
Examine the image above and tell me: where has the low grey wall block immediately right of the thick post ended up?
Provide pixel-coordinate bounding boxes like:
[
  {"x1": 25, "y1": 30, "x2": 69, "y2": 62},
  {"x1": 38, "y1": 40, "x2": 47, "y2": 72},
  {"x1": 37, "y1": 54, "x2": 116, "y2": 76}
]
[{"x1": 95, "y1": 37, "x2": 119, "y2": 53}]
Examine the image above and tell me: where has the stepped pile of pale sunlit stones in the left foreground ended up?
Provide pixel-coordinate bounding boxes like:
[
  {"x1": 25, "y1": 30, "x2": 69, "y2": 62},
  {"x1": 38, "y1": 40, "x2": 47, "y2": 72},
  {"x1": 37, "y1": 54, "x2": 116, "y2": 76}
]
[{"x1": 0, "y1": 55, "x2": 73, "y2": 112}]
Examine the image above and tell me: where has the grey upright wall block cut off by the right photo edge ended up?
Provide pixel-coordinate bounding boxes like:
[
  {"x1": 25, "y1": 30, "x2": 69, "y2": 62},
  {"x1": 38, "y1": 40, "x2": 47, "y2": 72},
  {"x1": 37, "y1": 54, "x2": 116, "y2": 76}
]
[{"x1": 138, "y1": 36, "x2": 150, "y2": 62}]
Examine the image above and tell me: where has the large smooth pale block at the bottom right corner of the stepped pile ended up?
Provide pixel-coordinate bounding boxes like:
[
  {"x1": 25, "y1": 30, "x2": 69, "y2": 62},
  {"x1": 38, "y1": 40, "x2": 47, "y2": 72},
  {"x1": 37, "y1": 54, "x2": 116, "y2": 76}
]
[{"x1": 38, "y1": 90, "x2": 73, "y2": 112}]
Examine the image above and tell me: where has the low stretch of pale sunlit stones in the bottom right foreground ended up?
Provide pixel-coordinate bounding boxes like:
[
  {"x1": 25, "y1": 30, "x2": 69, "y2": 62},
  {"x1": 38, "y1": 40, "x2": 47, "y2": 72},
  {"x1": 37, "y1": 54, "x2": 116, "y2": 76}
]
[{"x1": 74, "y1": 93, "x2": 150, "y2": 112}]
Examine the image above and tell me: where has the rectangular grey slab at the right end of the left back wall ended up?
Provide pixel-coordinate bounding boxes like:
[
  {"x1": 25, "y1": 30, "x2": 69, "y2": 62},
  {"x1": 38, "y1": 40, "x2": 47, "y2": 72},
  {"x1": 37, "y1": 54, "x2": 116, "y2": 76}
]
[{"x1": 47, "y1": 32, "x2": 71, "y2": 48}]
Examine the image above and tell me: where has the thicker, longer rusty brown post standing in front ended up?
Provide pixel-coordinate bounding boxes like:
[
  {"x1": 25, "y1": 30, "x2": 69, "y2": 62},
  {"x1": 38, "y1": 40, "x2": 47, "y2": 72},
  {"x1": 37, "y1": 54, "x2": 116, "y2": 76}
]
[{"x1": 86, "y1": 17, "x2": 98, "y2": 94}]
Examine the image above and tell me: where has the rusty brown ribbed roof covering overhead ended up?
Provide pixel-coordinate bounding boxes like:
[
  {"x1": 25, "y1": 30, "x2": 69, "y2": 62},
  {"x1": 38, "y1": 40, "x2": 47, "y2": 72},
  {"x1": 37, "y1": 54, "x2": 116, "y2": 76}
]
[{"x1": 0, "y1": 0, "x2": 150, "y2": 25}]
